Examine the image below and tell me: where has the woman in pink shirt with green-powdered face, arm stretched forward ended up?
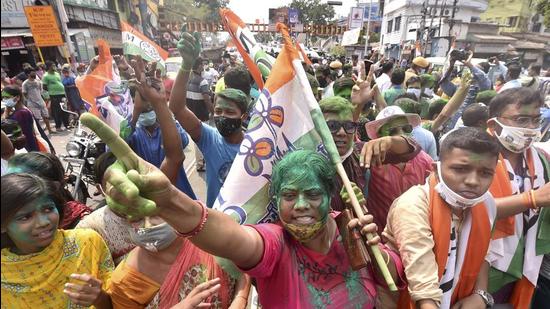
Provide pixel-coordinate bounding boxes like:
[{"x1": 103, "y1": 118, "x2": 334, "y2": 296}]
[{"x1": 82, "y1": 115, "x2": 410, "y2": 308}]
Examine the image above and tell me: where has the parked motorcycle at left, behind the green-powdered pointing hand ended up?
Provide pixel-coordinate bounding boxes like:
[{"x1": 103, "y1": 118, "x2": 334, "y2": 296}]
[{"x1": 61, "y1": 102, "x2": 105, "y2": 204}]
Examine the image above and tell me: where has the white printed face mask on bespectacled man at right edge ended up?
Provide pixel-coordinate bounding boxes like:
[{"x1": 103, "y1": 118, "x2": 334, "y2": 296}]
[{"x1": 492, "y1": 118, "x2": 541, "y2": 153}]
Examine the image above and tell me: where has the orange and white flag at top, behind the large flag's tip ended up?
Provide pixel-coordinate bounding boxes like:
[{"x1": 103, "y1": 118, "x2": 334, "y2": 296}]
[{"x1": 220, "y1": 9, "x2": 275, "y2": 89}]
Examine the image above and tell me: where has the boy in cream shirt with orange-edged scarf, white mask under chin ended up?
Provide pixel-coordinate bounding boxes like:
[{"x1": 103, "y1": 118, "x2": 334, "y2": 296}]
[{"x1": 383, "y1": 127, "x2": 498, "y2": 309}]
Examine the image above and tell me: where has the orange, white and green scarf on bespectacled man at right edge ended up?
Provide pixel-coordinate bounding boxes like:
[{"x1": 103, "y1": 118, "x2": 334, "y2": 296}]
[{"x1": 488, "y1": 147, "x2": 550, "y2": 308}]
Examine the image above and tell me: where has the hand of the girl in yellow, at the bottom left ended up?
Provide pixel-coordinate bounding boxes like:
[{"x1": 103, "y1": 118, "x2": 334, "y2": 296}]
[{"x1": 63, "y1": 274, "x2": 105, "y2": 307}]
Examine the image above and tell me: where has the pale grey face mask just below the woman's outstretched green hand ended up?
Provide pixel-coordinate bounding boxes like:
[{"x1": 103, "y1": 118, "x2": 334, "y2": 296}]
[{"x1": 128, "y1": 223, "x2": 178, "y2": 252}]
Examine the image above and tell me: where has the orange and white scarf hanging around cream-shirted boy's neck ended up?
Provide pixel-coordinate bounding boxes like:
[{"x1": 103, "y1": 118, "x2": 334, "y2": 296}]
[{"x1": 398, "y1": 173, "x2": 496, "y2": 309}]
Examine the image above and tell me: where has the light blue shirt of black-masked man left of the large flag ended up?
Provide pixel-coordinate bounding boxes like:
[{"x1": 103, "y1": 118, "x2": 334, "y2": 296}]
[{"x1": 198, "y1": 123, "x2": 240, "y2": 207}]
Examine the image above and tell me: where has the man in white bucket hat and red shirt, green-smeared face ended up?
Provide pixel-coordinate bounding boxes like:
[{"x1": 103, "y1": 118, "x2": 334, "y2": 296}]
[{"x1": 365, "y1": 106, "x2": 433, "y2": 229}]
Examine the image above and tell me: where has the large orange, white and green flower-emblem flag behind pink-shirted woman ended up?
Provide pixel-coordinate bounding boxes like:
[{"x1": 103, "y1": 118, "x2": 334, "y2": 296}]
[{"x1": 214, "y1": 23, "x2": 340, "y2": 224}]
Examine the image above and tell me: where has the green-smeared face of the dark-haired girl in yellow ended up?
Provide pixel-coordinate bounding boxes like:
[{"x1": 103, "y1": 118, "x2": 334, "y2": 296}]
[{"x1": 2, "y1": 197, "x2": 59, "y2": 255}]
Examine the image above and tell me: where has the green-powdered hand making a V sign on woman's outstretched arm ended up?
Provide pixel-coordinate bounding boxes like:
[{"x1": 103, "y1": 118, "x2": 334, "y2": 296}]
[{"x1": 80, "y1": 113, "x2": 172, "y2": 220}]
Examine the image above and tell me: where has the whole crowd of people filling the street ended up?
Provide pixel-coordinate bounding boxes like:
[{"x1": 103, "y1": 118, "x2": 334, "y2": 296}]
[{"x1": 1, "y1": 26, "x2": 550, "y2": 309}]
